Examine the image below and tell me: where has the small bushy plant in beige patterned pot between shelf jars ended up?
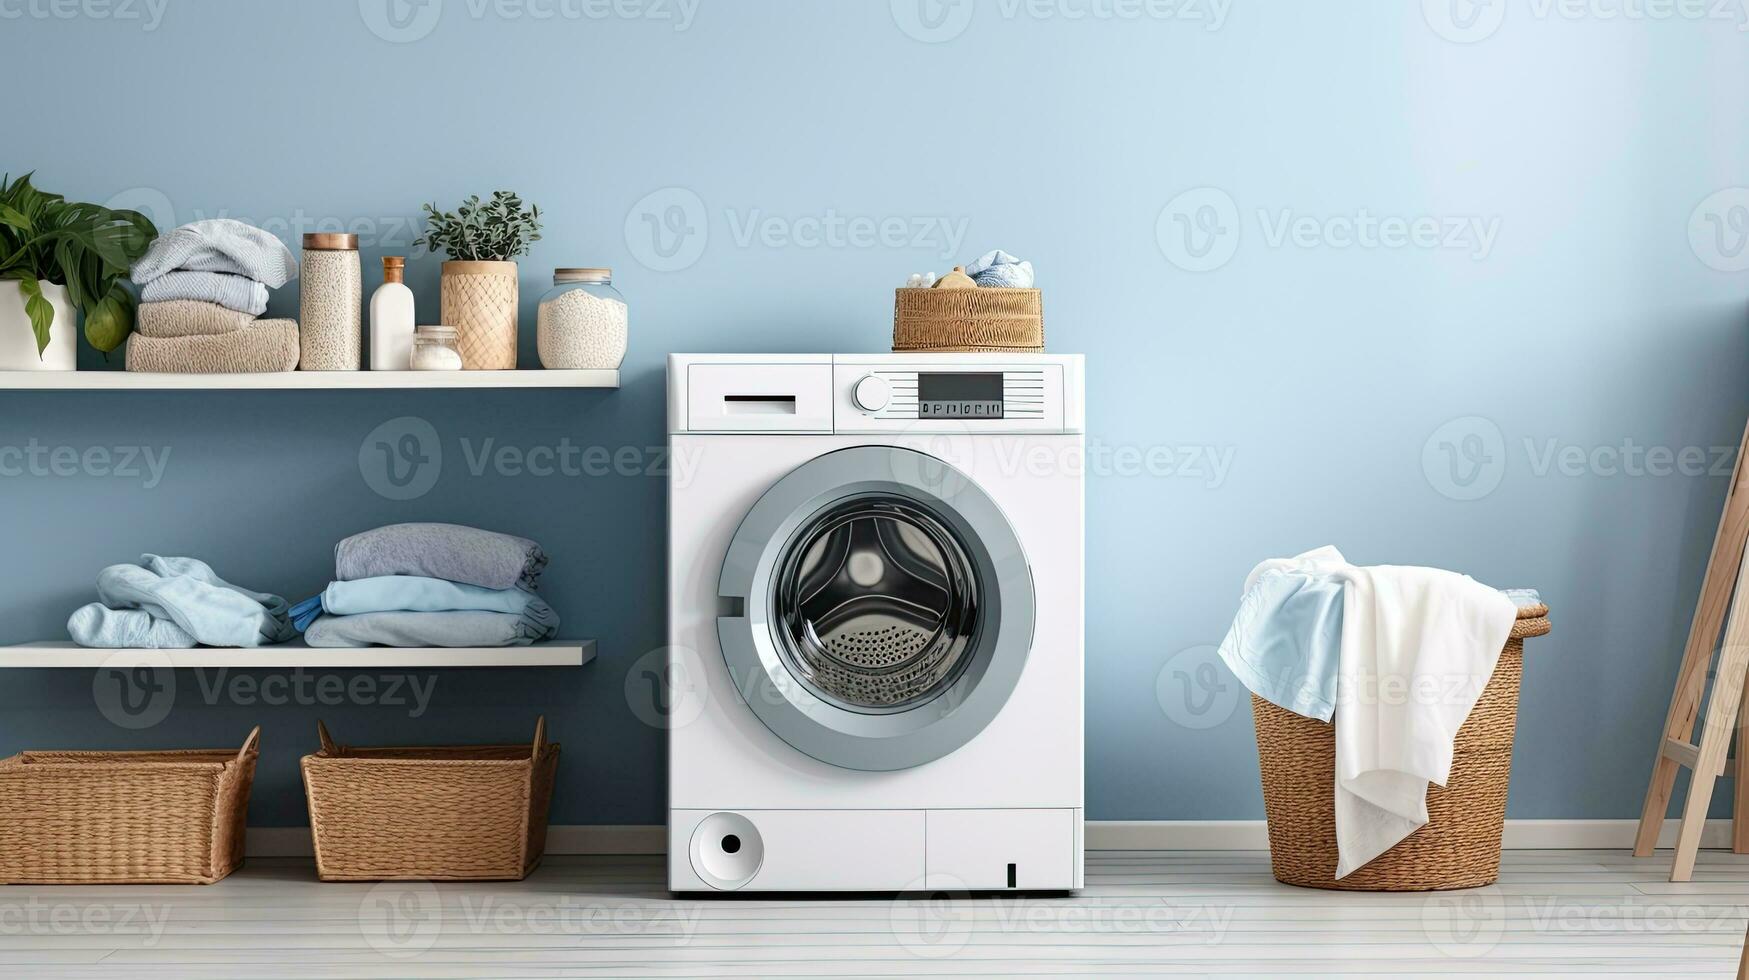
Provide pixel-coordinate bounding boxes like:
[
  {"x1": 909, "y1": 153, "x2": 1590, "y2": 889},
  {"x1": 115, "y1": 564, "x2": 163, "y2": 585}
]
[{"x1": 415, "y1": 191, "x2": 540, "y2": 371}]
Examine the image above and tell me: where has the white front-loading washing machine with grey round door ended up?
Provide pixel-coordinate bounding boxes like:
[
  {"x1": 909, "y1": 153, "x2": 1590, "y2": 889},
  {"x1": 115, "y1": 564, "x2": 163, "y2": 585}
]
[{"x1": 665, "y1": 354, "x2": 1084, "y2": 893}]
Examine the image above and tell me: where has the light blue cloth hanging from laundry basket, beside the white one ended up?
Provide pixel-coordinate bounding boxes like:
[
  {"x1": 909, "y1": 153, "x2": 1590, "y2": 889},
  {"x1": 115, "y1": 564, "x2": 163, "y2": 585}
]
[{"x1": 1221, "y1": 562, "x2": 1543, "y2": 721}]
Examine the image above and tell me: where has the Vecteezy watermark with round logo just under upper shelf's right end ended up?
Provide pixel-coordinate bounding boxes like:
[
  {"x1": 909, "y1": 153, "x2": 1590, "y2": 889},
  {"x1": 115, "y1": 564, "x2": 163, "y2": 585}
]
[{"x1": 359, "y1": 415, "x2": 705, "y2": 501}]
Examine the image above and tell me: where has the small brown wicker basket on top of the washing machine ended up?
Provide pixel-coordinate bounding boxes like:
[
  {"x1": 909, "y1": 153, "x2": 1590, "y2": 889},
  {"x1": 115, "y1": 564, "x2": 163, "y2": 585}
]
[{"x1": 892, "y1": 287, "x2": 1044, "y2": 354}]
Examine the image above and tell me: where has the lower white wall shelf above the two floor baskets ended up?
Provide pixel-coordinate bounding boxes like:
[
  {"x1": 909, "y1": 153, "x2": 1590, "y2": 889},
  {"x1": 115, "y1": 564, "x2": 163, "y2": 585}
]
[{"x1": 0, "y1": 641, "x2": 595, "y2": 670}]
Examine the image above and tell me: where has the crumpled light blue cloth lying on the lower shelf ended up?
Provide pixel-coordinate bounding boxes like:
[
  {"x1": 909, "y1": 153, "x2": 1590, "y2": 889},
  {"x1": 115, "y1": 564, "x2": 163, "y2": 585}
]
[{"x1": 66, "y1": 555, "x2": 297, "y2": 648}]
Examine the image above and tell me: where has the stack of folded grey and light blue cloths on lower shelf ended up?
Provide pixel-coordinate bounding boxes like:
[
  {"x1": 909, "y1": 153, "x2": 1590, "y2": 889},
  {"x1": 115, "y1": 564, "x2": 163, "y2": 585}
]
[{"x1": 292, "y1": 523, "x2": 558, "y2": 648}]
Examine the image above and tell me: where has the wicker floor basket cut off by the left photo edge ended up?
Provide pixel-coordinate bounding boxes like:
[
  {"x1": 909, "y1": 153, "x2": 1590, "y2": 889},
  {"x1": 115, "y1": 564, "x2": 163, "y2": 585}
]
[{"x1": 0, "y1": 728, "x2": 261, "y2": 886}]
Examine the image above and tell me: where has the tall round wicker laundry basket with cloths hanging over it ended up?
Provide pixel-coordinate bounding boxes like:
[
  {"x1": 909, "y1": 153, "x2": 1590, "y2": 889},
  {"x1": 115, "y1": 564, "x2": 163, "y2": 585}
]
[{"x1": 1251, "y1": 606, "x2": 1550, "y2": 891}]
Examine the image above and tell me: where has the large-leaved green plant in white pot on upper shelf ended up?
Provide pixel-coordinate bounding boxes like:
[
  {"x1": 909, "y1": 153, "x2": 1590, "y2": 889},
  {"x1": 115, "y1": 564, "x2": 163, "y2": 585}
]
[{"x1": 0, "y1": 173, "x2": 157, "y2": 371}]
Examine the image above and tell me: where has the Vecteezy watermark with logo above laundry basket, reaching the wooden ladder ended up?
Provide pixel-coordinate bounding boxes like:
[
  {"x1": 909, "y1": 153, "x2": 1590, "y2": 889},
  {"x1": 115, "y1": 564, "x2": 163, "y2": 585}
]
[{"x1": 1422, "y1": 415, "x2": 1737, "y2": 501}]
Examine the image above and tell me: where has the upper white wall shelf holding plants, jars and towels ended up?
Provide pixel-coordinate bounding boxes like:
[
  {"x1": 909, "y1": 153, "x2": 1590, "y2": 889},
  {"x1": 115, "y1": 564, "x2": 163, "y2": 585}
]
[{"x1": 0, "y1": 369, "x2": 619, "y2": 392}]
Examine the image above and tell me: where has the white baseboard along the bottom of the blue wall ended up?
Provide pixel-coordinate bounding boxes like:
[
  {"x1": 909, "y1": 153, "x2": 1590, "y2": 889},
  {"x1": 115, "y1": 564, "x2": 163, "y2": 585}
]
[{"x1": 248, "y1": 819, "x2": 1732, "y2": 858}]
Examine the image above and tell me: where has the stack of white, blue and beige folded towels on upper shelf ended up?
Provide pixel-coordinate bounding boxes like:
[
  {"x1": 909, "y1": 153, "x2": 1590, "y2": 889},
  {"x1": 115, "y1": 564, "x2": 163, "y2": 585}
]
[{"x1": 128, "y1": 217, "x2": 297, "y2": 375}]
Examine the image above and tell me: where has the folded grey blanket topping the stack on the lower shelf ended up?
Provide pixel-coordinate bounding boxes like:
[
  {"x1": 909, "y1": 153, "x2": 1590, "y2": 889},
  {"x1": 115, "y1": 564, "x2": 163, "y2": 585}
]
[{"x1": 334, "y1": 523, "x2": 547, "y2": 590}]
